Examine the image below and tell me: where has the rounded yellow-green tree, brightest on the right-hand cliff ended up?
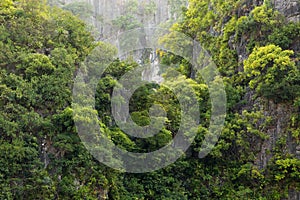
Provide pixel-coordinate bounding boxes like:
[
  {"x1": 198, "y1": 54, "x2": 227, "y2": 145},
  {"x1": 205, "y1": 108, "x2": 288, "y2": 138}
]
[{"x1": 244, "y1": 45, "x2": 300, "y2": 101}]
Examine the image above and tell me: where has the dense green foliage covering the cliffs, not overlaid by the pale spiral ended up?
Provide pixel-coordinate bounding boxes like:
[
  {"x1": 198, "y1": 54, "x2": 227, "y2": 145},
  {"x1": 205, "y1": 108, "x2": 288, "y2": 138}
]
[{"x1": 0, "y1": 0, "x2": 300, "y2": 199}]
